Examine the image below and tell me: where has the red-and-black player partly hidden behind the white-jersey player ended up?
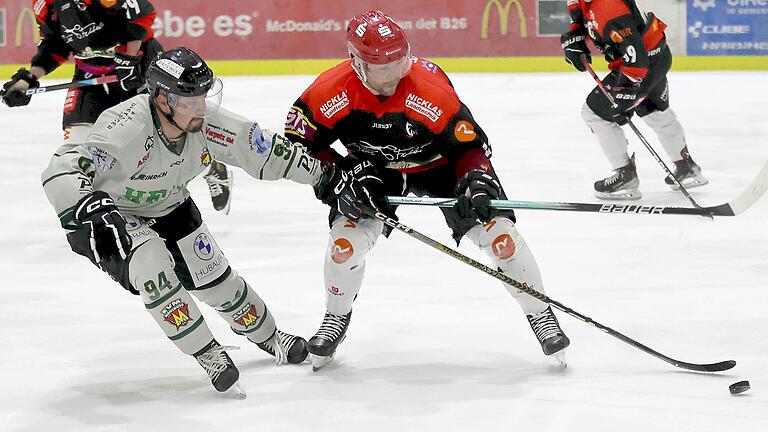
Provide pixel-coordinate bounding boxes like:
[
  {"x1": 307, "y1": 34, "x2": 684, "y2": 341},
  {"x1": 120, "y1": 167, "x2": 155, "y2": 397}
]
[{"x1": 0, "y1": 0, "x2": 232, "y2": 212}]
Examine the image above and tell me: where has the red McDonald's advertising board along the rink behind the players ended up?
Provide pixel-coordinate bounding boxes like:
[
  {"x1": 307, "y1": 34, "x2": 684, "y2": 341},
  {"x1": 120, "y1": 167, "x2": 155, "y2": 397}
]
[{"x1": 0, "y1": 0, "x2": 565, "y2": 64}]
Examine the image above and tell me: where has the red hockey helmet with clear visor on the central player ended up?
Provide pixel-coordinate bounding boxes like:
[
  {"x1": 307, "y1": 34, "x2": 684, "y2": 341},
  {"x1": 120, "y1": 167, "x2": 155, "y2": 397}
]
[{"x1": 347, "y1": 11, "x2": 413, "y2": 96}]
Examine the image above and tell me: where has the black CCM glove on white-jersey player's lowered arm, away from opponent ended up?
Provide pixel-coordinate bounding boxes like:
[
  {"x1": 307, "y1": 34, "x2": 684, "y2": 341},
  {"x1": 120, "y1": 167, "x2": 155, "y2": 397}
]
[{"x1": 75, "y1": 191, "x2": 132, "y2": 267}]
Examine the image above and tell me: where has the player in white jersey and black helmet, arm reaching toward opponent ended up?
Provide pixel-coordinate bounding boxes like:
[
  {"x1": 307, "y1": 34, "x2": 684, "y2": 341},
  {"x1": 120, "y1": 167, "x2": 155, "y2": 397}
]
[{"x1": 42, "y1": 48, "x2": 374, "y2": 395}]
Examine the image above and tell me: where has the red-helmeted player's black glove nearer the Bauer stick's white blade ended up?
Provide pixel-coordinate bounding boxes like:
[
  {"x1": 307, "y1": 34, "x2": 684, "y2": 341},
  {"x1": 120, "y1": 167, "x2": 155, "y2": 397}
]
[{"x1": 455, "y1": 169, "x2": 501, "y2": 222}]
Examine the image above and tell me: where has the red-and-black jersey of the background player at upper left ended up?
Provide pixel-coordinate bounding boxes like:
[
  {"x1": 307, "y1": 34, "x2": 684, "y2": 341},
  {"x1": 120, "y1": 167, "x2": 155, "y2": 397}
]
[{"x1": 31, "y1": 0, "x2": 157, "y2": 73}]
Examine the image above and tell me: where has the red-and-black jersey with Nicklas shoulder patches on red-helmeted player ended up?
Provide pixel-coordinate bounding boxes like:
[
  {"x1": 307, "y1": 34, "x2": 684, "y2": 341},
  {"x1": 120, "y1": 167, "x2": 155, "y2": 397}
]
[{"x1": 285, "y1": 57, "x2": 491, "y2": 176}]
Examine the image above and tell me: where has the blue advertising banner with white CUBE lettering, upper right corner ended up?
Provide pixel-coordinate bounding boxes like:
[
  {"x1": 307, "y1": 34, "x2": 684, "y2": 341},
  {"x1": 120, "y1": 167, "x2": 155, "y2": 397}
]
[{"x1": 688, "y1": 0, "x2": 768, "y2": 55}]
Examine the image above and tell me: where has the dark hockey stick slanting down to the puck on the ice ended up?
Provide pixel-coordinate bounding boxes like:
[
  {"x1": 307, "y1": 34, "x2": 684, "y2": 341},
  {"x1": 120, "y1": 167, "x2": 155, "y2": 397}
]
[{"x1": 360, "y1": 205, "x2": 736, "y2": 372}]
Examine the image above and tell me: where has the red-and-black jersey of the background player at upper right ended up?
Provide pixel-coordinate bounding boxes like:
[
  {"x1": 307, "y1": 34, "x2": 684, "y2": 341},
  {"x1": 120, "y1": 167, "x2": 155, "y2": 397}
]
[{"x1": 568, "y1": 0, "x2": 667, "y2": 82}]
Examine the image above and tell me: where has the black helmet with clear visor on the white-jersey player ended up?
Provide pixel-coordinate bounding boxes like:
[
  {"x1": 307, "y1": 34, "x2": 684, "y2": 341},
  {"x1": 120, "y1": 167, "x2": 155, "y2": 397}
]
[{"x1": 147, "y1": 47, "x2": 222, "y2": 117}]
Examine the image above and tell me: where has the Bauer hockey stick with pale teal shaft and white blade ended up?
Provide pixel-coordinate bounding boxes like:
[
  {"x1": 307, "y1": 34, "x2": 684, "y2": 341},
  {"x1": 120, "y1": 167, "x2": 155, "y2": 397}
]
[{"x1": 387, "y1": 154, "x2": 768, "y2": 216}]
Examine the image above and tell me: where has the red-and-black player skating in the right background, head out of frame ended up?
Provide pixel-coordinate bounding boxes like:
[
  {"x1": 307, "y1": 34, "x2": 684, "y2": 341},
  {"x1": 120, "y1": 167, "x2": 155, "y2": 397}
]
[{"x1": 561, "y1": 0, "x2": 708, "y2": 199}]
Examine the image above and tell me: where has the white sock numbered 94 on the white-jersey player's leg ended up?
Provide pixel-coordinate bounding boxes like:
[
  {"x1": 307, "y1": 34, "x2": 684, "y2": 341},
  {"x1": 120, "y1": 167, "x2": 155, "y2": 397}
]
[{"x1": 128, "y1": 238, "x2": 213, "y2": 355}]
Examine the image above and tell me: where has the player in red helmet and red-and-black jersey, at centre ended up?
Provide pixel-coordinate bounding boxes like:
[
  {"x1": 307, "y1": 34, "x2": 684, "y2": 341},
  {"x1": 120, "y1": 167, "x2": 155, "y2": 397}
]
[{"x1": 285, "y1": 11, "x2": 570, "y2": 368}]
